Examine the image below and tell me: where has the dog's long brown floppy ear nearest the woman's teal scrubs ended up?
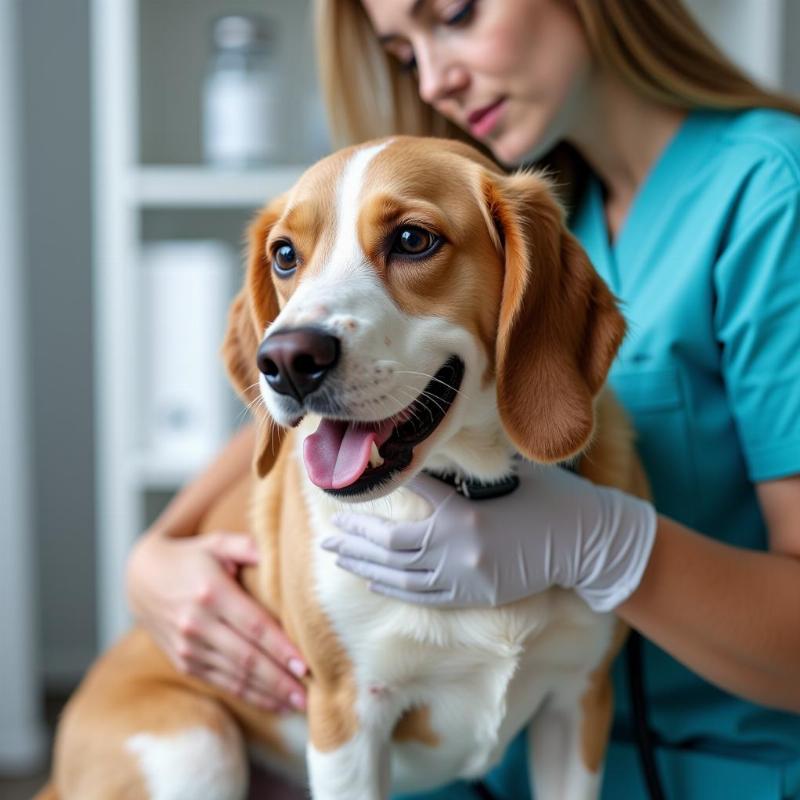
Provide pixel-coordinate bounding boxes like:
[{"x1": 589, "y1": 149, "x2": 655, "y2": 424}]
[{"x1": 482, "y1": 173, "x2": 625, "y2": 463}]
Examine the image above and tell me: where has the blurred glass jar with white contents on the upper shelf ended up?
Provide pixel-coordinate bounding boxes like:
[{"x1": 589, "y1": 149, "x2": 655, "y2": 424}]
[{"x1": 203, "y1": 14, "x2": 279, "y2": 168}]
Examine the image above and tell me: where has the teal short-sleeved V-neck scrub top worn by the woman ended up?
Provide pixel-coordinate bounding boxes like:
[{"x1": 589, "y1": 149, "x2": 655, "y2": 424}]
[{"x1": 396, "y1": 109, "x2": 800, "y2": 800}]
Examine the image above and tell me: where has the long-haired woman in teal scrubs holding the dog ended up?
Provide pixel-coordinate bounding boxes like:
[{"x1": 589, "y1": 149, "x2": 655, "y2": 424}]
[{"x1": 126, "y1": 0, "x2": 800, "y2": 798}]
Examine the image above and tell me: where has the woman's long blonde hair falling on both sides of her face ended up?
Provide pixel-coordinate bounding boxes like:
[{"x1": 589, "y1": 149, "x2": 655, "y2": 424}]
[{"x1": 315, "y1": 0, "x2": 800, "y2": 197}]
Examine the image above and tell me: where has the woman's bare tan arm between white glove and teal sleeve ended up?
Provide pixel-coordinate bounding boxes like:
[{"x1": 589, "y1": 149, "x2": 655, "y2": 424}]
[{"x1": 616, "y1": 476, "x2": 800, "y2": 712}]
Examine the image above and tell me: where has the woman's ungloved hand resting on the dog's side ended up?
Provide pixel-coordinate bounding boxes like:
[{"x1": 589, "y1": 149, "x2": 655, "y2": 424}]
[{"x1": 127, "y1": 531, "x2": 307, "y2": 711}]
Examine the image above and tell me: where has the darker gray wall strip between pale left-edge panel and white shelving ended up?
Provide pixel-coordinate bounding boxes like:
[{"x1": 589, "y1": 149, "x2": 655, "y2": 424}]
[{"x1": 18, "y1": 0, "x2": 95, "y2": 683}]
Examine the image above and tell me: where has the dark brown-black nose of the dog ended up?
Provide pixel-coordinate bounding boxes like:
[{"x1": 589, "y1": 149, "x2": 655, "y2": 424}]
[{"x1": 257, "y1": 328, "x2": 339, "y2": 402}]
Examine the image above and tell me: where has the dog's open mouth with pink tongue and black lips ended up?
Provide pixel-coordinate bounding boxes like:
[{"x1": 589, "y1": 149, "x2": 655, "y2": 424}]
[{"x1": 303, "y1": 356, "x2": 464, "y2": 497}]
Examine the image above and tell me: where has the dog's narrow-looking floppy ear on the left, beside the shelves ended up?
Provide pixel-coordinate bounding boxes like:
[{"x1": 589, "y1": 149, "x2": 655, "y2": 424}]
[{"x1": 222, "y1": 198, "x2": 285, "y2": 478}]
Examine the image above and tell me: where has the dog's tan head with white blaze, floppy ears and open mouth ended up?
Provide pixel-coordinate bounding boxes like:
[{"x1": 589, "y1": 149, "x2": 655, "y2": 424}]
[{"x1": 225, "y1": 137, "x2": 625, "y2": 500}]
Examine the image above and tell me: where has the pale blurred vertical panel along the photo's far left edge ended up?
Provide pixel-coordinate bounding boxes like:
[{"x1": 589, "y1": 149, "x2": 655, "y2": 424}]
[{"x1": 0, "y1": 0, "x2": 45, "y2": 772}]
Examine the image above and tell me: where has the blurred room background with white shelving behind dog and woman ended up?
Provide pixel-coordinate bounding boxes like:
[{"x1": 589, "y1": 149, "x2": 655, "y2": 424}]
[{"x1": 0, "y1": 0, "x2": 800, "y2": 800}]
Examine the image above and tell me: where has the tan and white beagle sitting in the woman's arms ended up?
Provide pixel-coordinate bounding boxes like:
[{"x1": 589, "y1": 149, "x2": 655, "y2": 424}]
[{"x1": 42, "y1": 137, "x2": 646, "y2": 800}]
